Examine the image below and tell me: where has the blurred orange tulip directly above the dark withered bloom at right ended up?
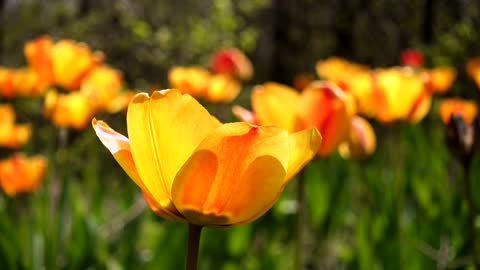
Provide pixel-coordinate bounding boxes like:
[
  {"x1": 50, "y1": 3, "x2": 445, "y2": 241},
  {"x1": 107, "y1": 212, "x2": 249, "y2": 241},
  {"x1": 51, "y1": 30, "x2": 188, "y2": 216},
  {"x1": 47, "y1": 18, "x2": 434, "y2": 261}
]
[{"x1": 439, "y1": 98, "x2": 478, "y2": 125}]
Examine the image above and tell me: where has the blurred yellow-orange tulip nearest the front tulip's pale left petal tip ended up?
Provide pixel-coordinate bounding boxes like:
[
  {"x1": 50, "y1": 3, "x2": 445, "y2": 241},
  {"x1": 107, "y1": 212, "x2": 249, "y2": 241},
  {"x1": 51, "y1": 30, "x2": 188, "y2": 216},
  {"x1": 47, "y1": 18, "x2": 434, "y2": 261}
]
[{"x1": 44, "y1": 90, "x2": 95, "y2": 130}]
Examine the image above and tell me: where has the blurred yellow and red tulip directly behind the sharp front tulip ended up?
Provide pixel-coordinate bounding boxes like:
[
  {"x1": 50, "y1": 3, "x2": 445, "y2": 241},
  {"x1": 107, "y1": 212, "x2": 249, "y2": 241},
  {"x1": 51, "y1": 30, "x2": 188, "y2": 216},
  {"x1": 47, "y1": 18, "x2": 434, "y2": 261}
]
[{"x1": 234, "y1": 81, "x2": 354, "y2": 156}]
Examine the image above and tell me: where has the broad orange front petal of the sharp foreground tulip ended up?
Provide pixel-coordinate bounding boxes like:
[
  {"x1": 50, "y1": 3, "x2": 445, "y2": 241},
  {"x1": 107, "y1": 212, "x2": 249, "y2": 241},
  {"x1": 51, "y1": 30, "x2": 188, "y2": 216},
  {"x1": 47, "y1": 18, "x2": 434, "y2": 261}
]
[{"x1": 172, "y1": 122, "x2": 290, "y2": 225}]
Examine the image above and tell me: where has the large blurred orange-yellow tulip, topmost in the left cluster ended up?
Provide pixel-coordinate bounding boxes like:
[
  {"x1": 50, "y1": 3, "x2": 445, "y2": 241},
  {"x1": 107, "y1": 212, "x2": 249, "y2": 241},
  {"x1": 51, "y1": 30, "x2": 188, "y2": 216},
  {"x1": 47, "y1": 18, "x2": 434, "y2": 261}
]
[{"x1": 24, "y1": 36, "x2": 103, "y2": 90}]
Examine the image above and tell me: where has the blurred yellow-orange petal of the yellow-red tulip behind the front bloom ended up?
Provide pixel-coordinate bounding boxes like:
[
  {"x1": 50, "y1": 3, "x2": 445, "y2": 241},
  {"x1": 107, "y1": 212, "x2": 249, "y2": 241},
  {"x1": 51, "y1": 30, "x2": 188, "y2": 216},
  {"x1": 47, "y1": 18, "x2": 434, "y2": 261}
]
[{"x1": 252, "y1": 82, "x2": 299, "y2": 132}]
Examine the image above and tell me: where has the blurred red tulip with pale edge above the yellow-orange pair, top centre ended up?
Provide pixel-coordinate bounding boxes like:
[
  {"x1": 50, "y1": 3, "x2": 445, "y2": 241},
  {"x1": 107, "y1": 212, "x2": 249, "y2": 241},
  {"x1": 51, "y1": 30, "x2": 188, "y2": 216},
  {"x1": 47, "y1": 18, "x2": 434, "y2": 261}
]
[{"x1": 210, "y1": 48, "x2": 253, "y2": 80}]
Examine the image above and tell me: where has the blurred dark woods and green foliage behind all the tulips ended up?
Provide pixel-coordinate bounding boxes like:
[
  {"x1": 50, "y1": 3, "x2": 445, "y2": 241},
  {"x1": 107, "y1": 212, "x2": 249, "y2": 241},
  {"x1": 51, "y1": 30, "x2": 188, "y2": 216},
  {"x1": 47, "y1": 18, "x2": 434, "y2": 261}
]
[{"x1": 0, "y1": 0, "x2": 480, "y2": 270}]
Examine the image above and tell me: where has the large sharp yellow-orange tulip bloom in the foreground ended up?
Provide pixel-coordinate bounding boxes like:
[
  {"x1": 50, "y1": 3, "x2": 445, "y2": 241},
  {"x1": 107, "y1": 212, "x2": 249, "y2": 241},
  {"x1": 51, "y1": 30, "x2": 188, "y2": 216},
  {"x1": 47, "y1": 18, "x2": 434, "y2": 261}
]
[{"x1": 93, "y1": 90, "x2": 321, "y2": 226}]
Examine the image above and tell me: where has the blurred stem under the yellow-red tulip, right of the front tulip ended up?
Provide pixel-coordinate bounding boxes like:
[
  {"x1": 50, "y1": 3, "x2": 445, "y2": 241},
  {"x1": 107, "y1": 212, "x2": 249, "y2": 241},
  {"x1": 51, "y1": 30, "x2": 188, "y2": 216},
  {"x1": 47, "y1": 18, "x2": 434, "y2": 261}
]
[{"x1": 295, "y1": 170, "x2": 305, "y2": 270}]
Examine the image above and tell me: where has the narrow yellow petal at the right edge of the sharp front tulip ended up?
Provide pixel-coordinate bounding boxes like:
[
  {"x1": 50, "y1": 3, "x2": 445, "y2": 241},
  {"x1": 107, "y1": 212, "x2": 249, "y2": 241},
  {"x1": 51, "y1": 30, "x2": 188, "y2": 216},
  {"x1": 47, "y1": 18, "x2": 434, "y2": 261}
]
[{"x1": 285, "y1": 128, "x2": 322, "y2": 184}]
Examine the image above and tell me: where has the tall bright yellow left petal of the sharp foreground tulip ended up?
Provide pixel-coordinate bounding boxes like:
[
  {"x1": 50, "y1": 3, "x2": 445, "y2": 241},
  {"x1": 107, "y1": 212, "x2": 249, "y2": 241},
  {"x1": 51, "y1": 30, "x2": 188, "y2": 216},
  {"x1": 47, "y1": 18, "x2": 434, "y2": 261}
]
[{"x1": 127, "y1": 90, "x2": 220, "y2": 214}]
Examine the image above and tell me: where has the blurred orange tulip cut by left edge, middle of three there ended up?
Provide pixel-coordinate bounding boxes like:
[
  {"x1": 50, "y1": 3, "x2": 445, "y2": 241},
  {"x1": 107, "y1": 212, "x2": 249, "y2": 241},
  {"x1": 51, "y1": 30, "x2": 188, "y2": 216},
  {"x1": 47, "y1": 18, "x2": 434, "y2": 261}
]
[{"x1": 0, "y1": 104, "x2": 31, "y2": 148}]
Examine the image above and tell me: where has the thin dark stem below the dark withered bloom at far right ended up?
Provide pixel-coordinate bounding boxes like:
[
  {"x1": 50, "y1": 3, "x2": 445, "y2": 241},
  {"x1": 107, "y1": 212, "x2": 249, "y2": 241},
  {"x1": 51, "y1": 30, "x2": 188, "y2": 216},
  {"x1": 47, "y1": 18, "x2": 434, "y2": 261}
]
[{"x1": 462, "y1": 160, "x2": 480, "y2": 269}]
